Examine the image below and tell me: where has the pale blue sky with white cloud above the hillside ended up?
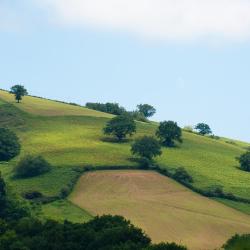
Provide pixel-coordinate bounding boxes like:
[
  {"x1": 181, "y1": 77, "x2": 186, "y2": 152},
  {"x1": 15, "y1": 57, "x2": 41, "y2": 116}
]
[{"x1": 0, "y1": 0, "x2": 250, "y2": 142}]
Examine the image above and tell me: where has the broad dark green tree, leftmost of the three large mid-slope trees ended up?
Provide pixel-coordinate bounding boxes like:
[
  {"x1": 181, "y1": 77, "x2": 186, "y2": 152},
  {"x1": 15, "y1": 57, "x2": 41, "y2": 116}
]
[{"x1": 103, "y1": 114, "x2": 136, "y2": 141}]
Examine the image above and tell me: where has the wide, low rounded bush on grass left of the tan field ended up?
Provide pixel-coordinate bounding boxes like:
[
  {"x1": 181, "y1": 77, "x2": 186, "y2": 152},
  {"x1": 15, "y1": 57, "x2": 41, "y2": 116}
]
[{"x1": 14, "y1": 155, "x2": 51, "y2": 177}]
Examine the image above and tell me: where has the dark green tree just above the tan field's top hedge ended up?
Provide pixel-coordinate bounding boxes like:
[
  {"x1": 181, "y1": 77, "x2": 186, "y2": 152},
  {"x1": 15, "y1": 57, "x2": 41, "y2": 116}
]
[{"x1": 131, "y1": 136, "x2": 162, "y2": 161}]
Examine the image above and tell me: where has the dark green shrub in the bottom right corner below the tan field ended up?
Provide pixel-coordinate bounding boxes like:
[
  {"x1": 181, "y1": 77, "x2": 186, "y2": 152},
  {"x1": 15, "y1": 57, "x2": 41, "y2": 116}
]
[{"x1": 223, "y1": 234, "x2": 250, "y2": 250}]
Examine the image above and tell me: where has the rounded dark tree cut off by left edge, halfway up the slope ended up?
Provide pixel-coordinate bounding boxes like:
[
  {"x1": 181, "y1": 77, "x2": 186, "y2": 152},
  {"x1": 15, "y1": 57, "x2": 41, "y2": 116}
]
[{"x1": 0, "y1": 128, "x2": 21, "y2": 161}]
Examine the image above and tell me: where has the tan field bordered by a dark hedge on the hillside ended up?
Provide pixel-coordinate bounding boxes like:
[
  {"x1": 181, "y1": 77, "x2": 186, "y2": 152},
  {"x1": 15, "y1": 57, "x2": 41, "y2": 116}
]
[{"x1": 70, "y1": 170, "x2": 250, "y2": 250}]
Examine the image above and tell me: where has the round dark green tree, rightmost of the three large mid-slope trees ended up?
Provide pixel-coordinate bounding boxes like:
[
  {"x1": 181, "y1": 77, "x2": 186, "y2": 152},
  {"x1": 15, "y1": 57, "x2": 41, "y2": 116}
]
[{"x1": 156, "y1": 121, "x2": 182, "y2": 147}]
